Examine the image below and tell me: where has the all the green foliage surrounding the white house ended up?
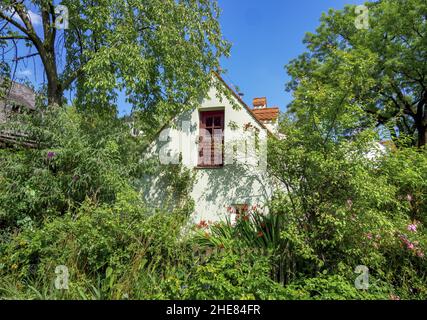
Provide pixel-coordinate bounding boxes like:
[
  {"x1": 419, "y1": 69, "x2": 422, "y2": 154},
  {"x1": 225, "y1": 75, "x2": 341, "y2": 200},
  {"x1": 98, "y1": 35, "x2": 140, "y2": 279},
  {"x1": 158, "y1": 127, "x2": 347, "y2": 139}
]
[{"x1": 0, "y1": 0, "x2": 427, "y2": 300}]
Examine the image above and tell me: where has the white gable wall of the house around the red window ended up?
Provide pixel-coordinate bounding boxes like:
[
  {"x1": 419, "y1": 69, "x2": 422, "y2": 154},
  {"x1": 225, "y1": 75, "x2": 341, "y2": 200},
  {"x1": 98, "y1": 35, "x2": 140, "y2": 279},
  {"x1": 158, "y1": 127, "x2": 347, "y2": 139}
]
[{"x1": 143, "y1": 79, "x2": 280, "y2": 223}]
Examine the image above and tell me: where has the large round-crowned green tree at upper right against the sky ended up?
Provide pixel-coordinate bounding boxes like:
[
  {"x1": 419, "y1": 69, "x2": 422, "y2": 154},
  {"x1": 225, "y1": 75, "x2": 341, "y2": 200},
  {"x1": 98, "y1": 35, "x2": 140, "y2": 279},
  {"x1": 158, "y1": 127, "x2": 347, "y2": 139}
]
[{"x1": 287, "y1": 0, "x2": 427, "y2": 146}]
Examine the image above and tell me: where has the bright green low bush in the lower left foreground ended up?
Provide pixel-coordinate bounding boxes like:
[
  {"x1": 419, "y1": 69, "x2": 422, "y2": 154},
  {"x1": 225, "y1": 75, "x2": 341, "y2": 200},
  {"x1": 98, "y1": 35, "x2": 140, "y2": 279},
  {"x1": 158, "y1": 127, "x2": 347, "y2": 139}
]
[{"x1": 0, "y1": 192, "x2": 191, "y2": 298}]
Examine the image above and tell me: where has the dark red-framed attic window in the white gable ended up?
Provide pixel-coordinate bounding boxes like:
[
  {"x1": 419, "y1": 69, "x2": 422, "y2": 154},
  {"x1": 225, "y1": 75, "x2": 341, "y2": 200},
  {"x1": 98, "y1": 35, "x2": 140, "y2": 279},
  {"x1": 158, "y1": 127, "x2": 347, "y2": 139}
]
[{"x1": 198, "y1": 110, "x2": 224, "y2": 167}]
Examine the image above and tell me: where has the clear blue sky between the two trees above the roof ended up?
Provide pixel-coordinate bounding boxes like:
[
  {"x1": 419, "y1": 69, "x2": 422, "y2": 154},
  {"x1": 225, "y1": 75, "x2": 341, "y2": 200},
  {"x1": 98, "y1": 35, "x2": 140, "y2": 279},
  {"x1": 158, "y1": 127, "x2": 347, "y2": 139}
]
[{"x1": 219, "y1": 0, "x2": 365, "y2": 110}]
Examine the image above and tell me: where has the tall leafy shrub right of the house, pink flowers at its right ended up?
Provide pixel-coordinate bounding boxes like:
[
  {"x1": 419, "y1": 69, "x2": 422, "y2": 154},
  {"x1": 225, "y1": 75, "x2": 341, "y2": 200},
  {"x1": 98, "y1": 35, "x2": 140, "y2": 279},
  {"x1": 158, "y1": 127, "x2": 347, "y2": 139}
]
[{"x1": 269, "y1": 116, "x2": 427, "y2": 298}]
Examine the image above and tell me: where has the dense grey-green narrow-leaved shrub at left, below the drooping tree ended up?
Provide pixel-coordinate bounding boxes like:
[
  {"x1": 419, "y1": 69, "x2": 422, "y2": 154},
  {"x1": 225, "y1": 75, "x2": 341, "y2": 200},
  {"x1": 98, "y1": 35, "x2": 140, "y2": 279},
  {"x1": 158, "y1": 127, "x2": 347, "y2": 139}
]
[{"x1": 0, "y1": 108, "x2": 138, "y2": 228}]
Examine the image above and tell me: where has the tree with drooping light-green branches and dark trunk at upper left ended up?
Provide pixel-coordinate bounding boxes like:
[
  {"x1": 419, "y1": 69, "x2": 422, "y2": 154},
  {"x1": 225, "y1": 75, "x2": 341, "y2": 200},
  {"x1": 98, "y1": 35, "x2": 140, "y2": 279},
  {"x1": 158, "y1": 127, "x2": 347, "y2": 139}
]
[{"x1": 0, "y1": 0, "x2": 229, "y2": 117}]
